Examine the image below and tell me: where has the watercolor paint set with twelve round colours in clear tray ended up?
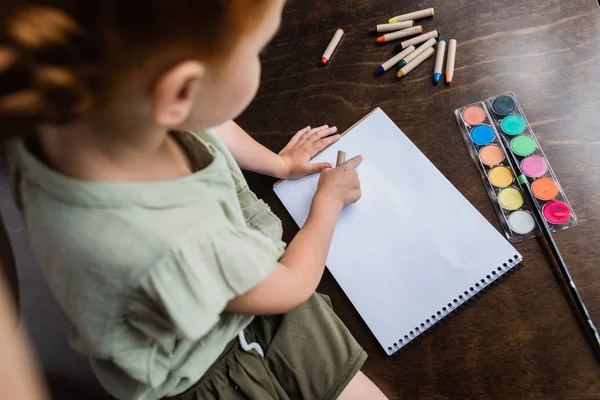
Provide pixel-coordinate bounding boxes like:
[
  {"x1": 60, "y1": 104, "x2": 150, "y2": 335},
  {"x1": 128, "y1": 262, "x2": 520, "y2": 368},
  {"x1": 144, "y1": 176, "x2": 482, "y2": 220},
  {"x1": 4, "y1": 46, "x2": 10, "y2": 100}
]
[{"x1": 454, "y1": 92, "x2": 577, "y2": 242}]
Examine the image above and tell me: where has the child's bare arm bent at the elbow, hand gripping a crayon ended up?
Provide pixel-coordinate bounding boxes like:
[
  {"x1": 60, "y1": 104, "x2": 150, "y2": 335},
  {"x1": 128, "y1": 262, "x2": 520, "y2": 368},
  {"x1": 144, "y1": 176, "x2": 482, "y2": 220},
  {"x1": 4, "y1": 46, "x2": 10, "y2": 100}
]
[{"x1": 226, "y1": 156, "x2": 362, "y2": 315}]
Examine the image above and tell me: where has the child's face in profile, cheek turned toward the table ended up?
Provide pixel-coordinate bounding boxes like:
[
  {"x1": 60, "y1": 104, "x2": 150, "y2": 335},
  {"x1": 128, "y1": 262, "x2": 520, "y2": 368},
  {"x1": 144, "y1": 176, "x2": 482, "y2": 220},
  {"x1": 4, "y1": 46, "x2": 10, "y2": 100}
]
[{"x1": 185, "y1": 0, "x2": 284, "y2": 129}]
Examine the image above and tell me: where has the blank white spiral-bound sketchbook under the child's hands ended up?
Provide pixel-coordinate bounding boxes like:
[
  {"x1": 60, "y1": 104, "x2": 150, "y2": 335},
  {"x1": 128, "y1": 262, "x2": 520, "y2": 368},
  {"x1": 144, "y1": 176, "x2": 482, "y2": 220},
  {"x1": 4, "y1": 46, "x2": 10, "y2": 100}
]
[{"x1": 275, "y1": 108, "x2": 522, "y2": 355}]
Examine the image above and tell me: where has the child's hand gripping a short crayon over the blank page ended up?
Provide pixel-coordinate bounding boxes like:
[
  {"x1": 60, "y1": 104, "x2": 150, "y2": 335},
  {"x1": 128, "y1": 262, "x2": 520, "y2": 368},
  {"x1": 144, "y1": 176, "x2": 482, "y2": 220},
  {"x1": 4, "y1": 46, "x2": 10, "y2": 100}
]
[{"x1": 315, "y1": 156, "x2": 363, "y2": 208}]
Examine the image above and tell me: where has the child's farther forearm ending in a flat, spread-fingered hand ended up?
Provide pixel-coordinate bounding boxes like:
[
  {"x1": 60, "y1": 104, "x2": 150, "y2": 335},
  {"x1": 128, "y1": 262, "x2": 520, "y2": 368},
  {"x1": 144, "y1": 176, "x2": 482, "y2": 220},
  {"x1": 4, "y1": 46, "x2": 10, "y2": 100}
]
[{"x1": 215, "y1": 121, "x2": 340, "y2": 179}]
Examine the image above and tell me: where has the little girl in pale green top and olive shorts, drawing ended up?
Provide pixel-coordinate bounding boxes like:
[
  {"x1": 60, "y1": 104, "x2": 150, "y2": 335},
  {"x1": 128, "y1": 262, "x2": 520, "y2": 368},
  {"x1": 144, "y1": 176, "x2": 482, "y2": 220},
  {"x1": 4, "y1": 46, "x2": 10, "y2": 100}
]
[{"x1": 0, "y1": 0, "x2": 384, "y2": 400}]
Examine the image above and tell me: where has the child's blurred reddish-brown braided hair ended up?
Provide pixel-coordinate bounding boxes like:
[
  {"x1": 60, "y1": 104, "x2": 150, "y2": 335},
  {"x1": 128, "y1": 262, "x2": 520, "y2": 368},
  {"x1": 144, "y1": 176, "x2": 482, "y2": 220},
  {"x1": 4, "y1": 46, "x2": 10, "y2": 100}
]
[{"x1": 0, "y1": 0, "x2": 269, "y2": 141}]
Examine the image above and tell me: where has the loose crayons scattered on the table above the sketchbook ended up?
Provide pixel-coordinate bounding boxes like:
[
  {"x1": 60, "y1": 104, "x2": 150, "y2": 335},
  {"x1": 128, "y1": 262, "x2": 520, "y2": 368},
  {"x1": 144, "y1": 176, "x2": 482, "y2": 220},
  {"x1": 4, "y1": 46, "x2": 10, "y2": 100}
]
[{"x1": 321, "y1": 8, "x2": 456, "y2": 83}]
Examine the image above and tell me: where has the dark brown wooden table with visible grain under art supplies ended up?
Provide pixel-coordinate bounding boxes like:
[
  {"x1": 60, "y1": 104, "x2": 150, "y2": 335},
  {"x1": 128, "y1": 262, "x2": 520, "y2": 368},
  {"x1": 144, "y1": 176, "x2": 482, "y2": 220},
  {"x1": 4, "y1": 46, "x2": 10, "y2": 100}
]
[{"x1": 239, "y1": 0, "x2": 600, "y2": 399}]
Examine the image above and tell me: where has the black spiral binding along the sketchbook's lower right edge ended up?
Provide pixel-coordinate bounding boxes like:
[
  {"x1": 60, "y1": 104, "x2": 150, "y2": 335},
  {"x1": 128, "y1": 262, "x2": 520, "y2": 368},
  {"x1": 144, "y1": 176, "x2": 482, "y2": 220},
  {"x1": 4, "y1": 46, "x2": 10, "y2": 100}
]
[{"x1": 387, "y1": 254, "x2": 523, "y2": 355}]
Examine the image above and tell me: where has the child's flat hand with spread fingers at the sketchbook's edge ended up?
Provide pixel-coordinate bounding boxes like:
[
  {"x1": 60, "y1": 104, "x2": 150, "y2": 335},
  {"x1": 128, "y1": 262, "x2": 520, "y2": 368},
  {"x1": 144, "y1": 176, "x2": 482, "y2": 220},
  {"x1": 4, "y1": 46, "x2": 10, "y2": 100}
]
[{"x1": 279, "y1": 125, "x2": 341, "y2": 179}]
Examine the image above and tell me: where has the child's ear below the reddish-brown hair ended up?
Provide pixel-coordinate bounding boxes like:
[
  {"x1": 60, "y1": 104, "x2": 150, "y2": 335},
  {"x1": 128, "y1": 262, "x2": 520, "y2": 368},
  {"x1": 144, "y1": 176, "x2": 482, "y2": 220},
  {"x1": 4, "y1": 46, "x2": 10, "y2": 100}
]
[{"x1": 152, "y1": 60, "x2": 205, "y2": 128}]
